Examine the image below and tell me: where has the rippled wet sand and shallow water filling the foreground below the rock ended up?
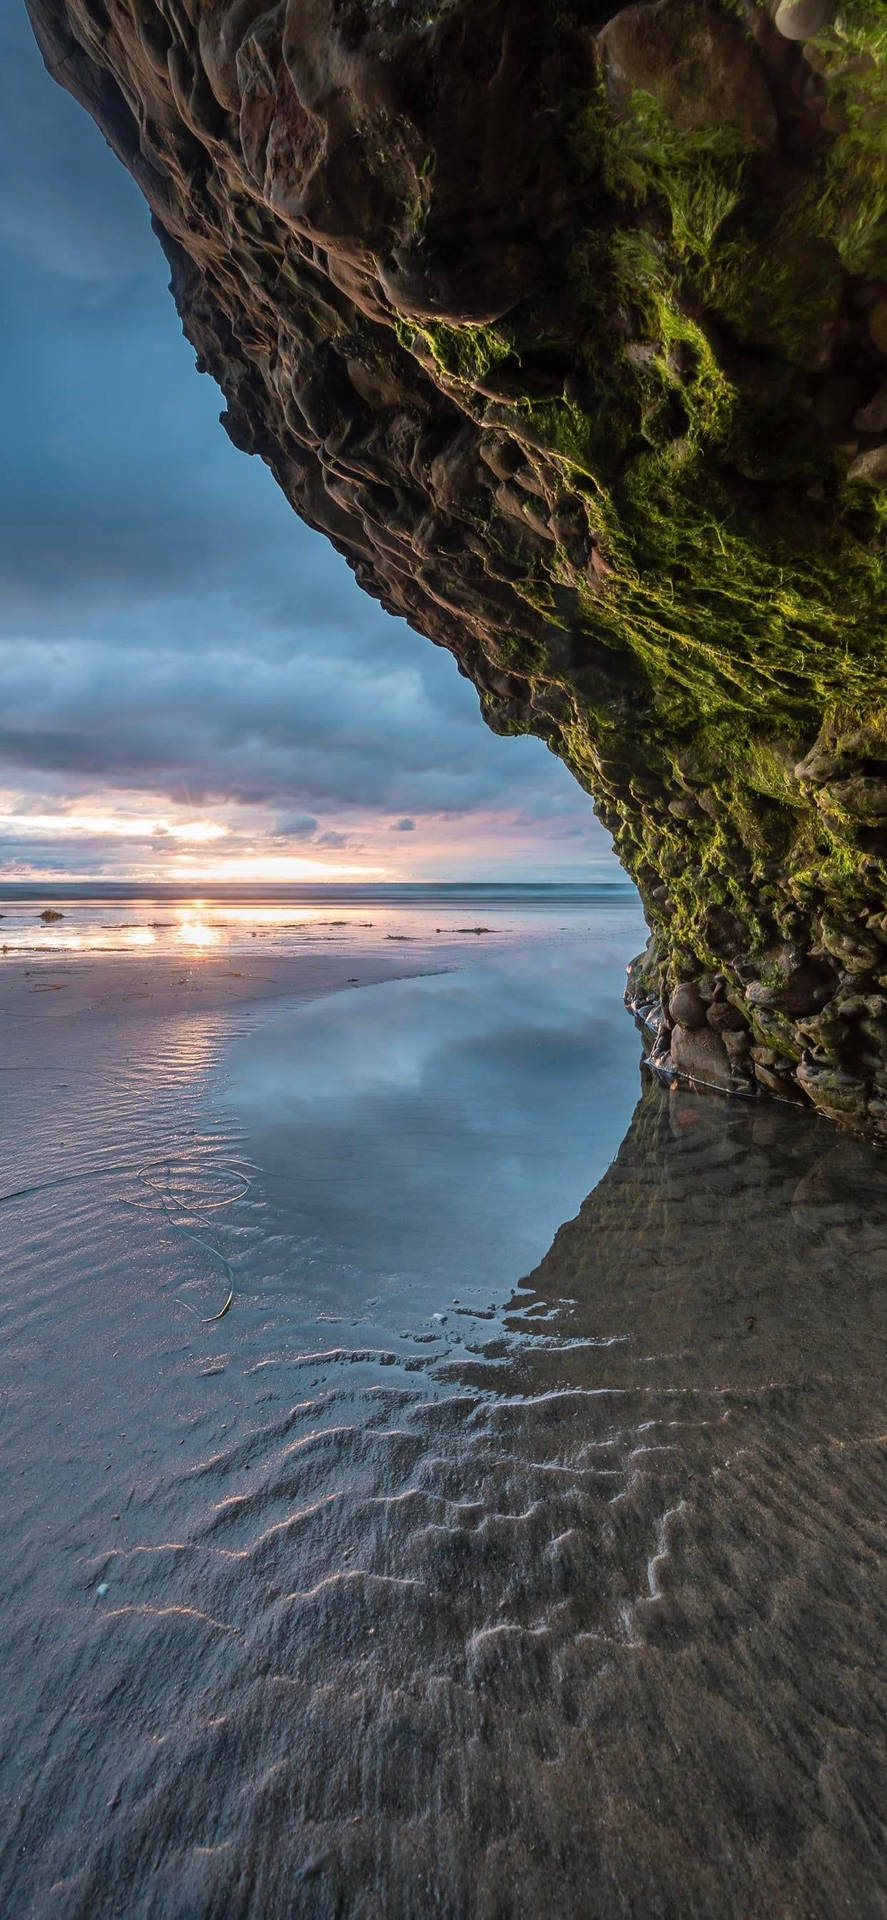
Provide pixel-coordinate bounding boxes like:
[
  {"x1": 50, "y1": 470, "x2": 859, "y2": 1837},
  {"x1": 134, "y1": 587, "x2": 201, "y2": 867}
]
[{"x1": 0, "y1": 922, "x2": 887, "y2": 1920}]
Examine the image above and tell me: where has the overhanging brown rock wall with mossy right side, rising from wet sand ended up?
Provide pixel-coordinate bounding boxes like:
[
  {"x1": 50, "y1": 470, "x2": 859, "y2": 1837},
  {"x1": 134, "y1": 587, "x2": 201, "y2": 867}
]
[{"x1": 29, "y1": 0, "x2": 887, "y2": 1133}]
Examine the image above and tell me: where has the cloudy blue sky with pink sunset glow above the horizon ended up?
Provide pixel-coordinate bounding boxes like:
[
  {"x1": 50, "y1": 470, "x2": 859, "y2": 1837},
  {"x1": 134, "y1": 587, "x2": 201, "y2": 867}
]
[{"x1": 0, "y1": 0, "x2": 618, "y2": 883}]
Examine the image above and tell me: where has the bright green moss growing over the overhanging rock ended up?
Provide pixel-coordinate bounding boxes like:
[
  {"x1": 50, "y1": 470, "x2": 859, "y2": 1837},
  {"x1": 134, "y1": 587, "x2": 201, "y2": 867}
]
[{"x1": 387, "y1": 18, "x2": 887, "y2": 1006}]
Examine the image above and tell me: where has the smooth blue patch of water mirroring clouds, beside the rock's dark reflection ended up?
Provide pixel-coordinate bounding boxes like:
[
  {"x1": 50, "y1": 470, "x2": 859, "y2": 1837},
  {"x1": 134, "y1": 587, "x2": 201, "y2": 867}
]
[{"x1": 216, "y1": 943, "x2": 639, "y2": 1321}]
